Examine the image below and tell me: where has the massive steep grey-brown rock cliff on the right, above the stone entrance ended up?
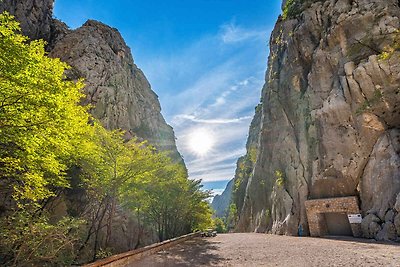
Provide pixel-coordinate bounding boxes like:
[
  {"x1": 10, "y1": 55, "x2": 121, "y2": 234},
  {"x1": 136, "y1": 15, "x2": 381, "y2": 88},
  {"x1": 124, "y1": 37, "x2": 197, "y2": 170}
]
[{"x1": 230, "y1": 0, "x2": 400, "y2": 240}]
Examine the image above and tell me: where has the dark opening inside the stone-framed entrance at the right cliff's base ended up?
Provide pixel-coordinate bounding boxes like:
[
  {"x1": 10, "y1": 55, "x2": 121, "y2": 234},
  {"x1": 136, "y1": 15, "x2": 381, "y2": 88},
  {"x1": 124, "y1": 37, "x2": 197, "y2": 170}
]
[{"x1": 324, "y1": 212, "x2": 353, "y2": 236}]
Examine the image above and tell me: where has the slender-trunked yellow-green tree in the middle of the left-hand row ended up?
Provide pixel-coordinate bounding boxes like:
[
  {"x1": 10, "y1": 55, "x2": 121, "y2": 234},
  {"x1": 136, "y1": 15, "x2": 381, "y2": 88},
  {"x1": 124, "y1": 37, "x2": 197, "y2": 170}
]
[{"x1": 80, "y1": 123, "x2": 159, "y2": 260}]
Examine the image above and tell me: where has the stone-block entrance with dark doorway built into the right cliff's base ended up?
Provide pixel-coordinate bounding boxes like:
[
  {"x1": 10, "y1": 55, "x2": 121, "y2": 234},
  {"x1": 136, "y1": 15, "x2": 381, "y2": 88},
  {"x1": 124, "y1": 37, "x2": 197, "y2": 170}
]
[{"x1": 305, "y1": 197, "x2": 361, "y2": 237}]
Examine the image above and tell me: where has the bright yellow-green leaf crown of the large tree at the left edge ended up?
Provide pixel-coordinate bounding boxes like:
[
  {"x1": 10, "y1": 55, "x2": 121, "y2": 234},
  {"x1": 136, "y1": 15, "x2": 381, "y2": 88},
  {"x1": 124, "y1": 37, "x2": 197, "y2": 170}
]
[{"x1": 0, "y1": 13, "x2": 89, "y2": 203}]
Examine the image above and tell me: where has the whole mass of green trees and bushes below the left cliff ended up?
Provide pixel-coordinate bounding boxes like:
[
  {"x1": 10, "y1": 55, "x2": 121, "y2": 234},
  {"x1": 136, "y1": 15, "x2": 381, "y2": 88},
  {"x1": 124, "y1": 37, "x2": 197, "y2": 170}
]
[{"x1": 0, "y1": 13, "x2": 211, "y2": 266}]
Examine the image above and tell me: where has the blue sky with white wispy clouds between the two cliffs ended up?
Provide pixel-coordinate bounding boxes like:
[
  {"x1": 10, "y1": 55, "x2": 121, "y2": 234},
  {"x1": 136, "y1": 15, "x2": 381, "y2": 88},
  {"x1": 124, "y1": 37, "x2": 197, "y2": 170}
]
[{"x1": 54, "y1": 0, "x2": 281, "y2": 196}]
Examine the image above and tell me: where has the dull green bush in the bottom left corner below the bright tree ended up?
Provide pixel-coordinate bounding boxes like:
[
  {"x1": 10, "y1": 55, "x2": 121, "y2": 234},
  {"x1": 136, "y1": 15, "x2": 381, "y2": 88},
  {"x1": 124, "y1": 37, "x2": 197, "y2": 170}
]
[{"x1": 0, "y1": 211, "x2": 84, "y2": 266}]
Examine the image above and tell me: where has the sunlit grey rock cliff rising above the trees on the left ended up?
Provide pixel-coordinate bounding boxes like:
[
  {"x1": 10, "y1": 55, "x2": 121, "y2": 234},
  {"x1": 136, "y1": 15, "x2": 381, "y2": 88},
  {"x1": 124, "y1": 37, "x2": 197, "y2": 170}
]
[{"x1": 0, "y1": 0, "x2": 182, "y2": 161}]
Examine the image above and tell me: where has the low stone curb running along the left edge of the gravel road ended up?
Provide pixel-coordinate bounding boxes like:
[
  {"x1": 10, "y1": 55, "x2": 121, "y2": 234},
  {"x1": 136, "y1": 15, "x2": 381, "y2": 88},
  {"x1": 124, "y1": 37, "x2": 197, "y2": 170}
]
[{"x1": 83, "y1": 232, "x2": 201, "y2": 267}]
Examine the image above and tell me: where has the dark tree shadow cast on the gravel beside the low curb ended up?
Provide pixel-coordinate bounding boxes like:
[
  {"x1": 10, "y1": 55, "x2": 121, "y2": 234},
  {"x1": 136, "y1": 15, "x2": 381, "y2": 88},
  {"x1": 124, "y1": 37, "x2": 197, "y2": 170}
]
[{"x1": 162, "y1": 238, "x2": 225, "y2": 266}]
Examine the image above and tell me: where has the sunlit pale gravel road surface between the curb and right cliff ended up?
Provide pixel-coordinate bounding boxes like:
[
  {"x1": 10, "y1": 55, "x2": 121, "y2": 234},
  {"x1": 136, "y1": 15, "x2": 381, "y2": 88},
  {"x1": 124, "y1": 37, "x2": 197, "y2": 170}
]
[{"x1": 130, "y1": 234, "x2": 400, "y2": 267}]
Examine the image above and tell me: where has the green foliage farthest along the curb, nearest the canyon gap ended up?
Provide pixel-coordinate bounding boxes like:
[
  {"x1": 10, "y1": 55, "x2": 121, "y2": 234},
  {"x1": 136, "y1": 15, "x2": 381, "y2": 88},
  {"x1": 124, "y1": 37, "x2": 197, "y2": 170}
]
[{"x1": 123, "y1": 157, "x2": 212, "y2": 240}]
